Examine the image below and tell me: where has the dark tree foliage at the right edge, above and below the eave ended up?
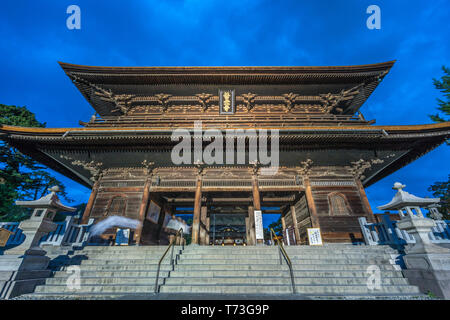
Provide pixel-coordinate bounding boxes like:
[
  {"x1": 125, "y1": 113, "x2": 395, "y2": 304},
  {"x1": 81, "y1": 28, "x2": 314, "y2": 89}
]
[{"x1": 428, "y1": 66, "x2": 450, "y2": 219}]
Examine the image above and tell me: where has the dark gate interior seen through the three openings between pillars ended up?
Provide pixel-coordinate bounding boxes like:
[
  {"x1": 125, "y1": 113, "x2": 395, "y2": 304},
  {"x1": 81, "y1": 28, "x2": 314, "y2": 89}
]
[{"x1": 139, "y1": 191, "x2": 311, "y2": 246}]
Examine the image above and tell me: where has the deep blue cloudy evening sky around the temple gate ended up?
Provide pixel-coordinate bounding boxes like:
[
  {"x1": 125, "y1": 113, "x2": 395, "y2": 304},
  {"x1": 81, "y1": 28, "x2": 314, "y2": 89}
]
[{"x1": 0, "y1": 0, "x2": 450, "y2": 228}]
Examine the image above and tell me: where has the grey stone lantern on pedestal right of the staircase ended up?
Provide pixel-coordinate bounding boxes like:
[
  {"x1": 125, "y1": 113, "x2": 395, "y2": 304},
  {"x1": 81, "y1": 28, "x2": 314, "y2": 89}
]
[{"x1": 378, "y1": 182, "x2": 450, "y2": 299}]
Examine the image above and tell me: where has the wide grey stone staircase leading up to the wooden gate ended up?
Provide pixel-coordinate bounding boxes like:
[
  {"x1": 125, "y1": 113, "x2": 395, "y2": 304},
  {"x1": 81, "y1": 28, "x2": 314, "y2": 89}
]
[{"x1": 18, "y1": 244, "x2": 423, "y2": 299}]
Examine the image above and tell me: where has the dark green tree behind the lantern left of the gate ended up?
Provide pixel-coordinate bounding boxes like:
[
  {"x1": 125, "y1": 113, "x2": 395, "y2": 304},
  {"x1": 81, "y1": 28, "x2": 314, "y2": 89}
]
[{"x1": 0, "y1": 104, "x2": 72, "y2": 221}]
